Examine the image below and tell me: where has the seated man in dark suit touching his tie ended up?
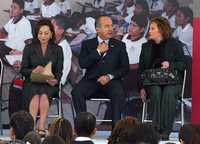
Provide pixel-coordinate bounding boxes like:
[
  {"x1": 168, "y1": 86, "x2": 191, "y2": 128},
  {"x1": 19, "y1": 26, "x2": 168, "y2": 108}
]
[{"x1": 72, "y1": 16, "x2": 129, "y2": 124}]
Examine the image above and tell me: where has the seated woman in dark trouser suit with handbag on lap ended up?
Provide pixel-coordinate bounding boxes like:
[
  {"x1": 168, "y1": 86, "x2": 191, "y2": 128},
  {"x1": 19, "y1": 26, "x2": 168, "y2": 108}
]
[{"x1": 139, "y1": 18, "x2": 185, "y2": 139}]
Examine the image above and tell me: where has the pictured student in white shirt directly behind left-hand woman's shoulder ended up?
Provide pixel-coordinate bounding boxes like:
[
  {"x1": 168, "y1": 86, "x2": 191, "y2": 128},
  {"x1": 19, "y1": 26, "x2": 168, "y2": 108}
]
[{"x1": 52, "y1": 16, "x2": 72, "y2": 85}]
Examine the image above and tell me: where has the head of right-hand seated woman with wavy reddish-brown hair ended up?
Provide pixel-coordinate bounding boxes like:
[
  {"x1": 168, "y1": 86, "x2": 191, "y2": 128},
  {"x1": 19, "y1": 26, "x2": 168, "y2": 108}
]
[{"x1": 149, "y1": 17, "x2": 172, "y2": 43}]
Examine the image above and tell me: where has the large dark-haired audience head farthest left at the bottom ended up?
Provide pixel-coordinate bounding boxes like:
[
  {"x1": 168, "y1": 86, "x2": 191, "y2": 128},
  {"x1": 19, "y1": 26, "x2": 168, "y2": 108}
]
[{"x1": 10, "y1": 111, "x2": 34, "y2": 140}]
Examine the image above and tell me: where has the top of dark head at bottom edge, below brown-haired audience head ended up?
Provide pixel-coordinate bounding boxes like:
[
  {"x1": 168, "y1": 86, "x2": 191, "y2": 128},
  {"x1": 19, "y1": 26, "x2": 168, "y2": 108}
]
[{"x1": 42, "y1": 136, "x2": 65, "y2": 144}]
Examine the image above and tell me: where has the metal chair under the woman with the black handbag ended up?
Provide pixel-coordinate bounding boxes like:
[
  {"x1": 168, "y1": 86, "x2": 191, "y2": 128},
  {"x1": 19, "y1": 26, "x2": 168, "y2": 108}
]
[{"x1": 142, "y1": 70, "x2": 188, "y2": 126}]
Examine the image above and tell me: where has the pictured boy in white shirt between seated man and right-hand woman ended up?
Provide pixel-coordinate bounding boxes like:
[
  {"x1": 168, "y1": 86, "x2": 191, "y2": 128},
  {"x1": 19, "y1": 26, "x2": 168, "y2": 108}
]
[{"x1": 122, "y1": 14, "x2": 148, "y2": 95}]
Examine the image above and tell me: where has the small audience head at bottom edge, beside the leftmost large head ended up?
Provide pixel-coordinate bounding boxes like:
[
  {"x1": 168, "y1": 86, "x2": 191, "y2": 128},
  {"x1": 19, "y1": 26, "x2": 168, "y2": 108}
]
[{"x1": 23, "y1": 131, "x2": 41, "y2": 144}]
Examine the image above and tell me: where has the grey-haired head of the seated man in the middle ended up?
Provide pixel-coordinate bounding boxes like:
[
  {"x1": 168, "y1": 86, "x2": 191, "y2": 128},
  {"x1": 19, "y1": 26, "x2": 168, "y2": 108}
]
[{"x1": 95, "y1": 15, "x2": 113, "y2": 40}]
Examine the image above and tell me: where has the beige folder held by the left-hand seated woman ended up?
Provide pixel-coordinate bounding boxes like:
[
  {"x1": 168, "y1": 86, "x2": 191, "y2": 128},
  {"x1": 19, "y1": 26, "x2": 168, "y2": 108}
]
[{"x1": 31, "y1": 62, "x2": 54, "y2": 83}]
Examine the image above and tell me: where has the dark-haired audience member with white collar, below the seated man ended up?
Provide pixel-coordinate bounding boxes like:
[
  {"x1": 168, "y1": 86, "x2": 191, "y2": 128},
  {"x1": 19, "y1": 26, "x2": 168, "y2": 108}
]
[{"x1": 74, "y1": 112, "x2": 96, "y2": 144}]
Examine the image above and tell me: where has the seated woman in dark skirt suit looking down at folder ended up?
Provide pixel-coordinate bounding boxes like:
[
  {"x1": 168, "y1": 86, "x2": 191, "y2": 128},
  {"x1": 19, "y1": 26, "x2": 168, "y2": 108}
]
[{"x1": 21, "y1": 19, "x2": 63, "y2": 134}]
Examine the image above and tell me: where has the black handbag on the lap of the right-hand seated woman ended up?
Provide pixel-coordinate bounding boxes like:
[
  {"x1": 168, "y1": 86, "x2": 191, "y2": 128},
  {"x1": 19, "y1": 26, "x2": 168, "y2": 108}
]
[{"x1": 140, "y1": 68, "x2": 181, "y2": 86}]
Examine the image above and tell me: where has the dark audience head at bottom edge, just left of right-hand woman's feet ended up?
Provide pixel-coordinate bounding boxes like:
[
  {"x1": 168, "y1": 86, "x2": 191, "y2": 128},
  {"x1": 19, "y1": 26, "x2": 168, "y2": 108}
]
[{"x1": 129, "y1": 123, "x2": 160, "y2": 144}]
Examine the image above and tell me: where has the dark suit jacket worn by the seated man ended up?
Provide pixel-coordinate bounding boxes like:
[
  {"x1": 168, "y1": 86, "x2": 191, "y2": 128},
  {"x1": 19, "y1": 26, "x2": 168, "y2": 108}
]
[{"x1": 79, "y1": 37, "x2": 129, "y2": 80}]
